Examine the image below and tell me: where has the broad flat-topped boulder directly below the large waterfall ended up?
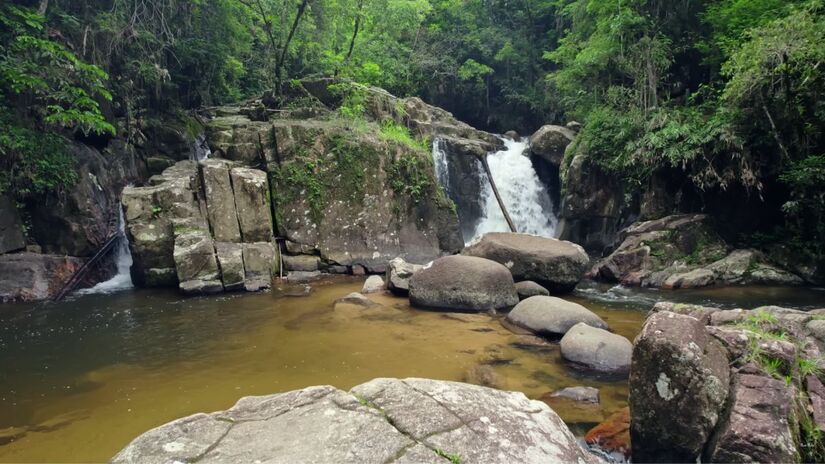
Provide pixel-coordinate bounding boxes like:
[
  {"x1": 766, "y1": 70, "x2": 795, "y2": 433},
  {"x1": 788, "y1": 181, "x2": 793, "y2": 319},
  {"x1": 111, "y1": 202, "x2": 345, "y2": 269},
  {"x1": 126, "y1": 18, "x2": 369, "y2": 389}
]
[{"x1": 461, "y1": 232, "x2": 590, "y2": 293}]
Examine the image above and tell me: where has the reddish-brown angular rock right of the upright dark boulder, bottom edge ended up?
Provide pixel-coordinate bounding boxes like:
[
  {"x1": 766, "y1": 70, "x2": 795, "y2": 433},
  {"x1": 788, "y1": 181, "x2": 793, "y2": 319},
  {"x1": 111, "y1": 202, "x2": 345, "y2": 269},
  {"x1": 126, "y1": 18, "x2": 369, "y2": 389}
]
[{"x1": 708, "y1": 374, "x2": 800, "y2": 462}]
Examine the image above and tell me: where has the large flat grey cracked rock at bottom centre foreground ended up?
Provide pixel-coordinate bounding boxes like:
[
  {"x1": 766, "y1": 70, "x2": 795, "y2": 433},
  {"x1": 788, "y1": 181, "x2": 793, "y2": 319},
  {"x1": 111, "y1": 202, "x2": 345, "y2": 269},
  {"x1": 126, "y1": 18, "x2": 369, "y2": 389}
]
[{"x1": 113, "y1": 379, "x2": 600, "y2": 464}]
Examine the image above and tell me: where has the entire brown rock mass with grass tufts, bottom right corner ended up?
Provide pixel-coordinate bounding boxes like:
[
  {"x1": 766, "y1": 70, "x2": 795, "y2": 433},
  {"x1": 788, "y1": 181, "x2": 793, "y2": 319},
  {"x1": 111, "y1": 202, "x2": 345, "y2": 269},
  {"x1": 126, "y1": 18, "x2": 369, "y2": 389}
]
[{"x1": 630, "y1": 303, "x2": 825, "y2": 462}]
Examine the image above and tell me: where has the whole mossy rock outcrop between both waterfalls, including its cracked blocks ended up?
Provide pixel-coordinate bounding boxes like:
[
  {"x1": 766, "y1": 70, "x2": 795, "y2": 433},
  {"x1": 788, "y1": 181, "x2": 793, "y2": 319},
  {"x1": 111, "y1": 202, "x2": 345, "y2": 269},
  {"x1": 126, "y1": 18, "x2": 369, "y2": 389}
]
[{"x1": 123, "y1": 81, "x2": 498, "y2": 292}]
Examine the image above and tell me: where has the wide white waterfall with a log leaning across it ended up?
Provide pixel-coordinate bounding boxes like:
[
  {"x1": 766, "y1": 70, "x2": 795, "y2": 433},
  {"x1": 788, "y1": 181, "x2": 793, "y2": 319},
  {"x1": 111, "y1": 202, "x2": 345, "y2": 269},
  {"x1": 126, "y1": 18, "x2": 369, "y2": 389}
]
[{"x1": 474, "y1": 139, "x2": 558, "y2": 238}]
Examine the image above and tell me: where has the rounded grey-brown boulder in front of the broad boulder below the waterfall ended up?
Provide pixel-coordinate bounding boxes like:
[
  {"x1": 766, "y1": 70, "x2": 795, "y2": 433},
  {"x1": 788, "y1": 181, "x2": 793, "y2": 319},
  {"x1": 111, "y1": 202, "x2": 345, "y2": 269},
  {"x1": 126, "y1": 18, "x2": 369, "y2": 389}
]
[{"x1": 409, "y1": 255, "x2": 518, "y2": 311}]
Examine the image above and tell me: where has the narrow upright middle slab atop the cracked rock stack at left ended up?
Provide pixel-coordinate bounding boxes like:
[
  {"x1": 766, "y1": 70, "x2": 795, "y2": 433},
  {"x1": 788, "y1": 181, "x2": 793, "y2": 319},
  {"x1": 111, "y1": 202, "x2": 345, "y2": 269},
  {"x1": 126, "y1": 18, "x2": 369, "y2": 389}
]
[{"x1": 201, "y1": 159, "x2": 241, "y2": 242}]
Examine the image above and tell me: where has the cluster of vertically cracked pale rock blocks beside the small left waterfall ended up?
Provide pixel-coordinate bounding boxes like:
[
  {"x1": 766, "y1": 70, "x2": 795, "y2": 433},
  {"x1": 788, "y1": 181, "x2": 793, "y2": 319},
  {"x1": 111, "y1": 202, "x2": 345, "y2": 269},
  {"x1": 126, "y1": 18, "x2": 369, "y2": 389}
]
[{"x1": 122, "y1": 160, "x2": 278, "y2": 293}]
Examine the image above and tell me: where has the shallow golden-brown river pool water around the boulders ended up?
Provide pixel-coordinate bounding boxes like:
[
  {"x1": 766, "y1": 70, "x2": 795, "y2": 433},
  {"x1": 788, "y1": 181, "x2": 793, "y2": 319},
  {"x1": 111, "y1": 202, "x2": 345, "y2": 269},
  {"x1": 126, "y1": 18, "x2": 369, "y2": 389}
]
[{"x1": 0, "y1": 277, "x2": 825, "y2": 462}]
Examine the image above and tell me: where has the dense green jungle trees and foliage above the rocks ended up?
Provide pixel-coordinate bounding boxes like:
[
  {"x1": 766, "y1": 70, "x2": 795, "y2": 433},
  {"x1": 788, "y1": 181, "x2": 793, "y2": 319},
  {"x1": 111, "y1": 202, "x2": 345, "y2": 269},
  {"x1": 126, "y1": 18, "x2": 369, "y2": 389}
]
[{"x1": 0, "y1": 0, "x2": 825, "y2": 256}]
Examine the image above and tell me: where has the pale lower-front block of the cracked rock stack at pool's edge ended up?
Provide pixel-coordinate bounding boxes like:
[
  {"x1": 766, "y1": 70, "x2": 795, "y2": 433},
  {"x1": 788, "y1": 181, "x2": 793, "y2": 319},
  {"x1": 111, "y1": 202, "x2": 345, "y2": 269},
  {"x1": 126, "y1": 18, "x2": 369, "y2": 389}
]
[{"x1": 173, "y1": 232, "x2": 223, "y2": 293}]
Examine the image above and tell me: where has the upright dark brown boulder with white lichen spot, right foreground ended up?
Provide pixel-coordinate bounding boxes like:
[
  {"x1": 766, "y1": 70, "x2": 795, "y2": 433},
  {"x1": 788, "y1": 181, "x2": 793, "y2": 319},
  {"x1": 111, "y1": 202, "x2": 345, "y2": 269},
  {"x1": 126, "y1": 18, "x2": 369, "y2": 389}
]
[{"x1": 630, "y1": 312, "x2": 730, "y2": 462}]
